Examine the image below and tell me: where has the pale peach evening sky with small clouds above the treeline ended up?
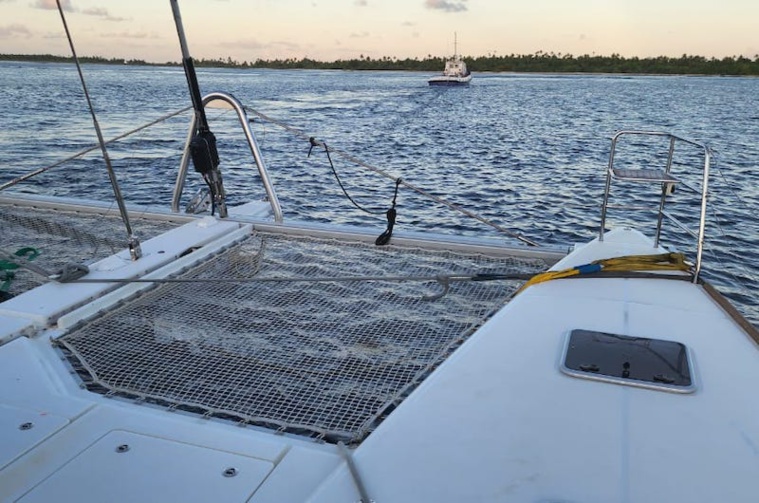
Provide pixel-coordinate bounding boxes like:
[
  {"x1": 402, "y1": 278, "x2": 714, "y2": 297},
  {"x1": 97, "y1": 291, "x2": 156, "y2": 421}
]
[{"x1": 0, "y1": 0, "x2": 759, "y2": 63}]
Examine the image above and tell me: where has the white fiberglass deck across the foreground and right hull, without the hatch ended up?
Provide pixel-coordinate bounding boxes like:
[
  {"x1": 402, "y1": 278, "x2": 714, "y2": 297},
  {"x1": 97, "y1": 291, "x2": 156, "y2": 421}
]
[{"x1": 0, "y1": 231, "x2": 759, "y2": 503}]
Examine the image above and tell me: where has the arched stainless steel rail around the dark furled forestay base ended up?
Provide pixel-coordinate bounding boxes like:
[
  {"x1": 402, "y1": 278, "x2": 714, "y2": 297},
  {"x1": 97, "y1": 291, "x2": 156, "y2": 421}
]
[{"x1": 171, "y1": 92, "x2": 283, "y2": 223}]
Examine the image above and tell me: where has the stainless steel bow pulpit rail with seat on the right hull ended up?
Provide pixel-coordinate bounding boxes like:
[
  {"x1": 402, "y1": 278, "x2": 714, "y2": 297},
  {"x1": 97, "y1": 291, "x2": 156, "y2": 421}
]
[{"x1": 598, "y1": 131, "x2": 711, "y2": 283}]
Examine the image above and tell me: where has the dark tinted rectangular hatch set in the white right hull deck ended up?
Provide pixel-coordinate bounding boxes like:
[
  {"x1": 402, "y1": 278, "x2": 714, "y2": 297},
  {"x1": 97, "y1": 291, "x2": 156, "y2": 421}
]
[{"x1": 561, "y1": 329, "x2": 694, "y2": 393}]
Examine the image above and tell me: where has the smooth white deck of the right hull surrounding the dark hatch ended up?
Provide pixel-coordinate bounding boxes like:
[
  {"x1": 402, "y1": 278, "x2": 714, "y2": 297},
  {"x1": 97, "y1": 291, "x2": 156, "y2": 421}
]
[{"x1": 311, "y1": 231, "x2": 759, "y2": 503}]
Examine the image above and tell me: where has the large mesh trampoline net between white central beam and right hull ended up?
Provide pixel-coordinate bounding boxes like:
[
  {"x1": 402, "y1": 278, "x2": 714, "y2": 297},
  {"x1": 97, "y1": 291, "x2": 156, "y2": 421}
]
[{"x1": 58, "y1": 233, "x2": 546, "y2": 444}]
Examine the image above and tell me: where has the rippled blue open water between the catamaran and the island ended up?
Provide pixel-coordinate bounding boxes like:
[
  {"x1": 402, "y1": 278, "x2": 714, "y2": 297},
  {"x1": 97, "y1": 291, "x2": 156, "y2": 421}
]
[{"x1": 0, "y1": 62, "x2": 759, "y2": 324}]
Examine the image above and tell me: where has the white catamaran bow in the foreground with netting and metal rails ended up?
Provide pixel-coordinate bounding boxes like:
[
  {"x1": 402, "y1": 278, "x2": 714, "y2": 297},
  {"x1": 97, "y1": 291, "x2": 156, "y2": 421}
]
[{"x1": 0, "y1": 3, "x2": 759, "y2": 503}]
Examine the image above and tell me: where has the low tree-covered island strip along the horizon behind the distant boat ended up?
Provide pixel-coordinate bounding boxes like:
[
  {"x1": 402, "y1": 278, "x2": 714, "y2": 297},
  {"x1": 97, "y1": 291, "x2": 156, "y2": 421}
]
[{"x1": 0, "y1": 51, "x2": 759, "y2": 76}]
